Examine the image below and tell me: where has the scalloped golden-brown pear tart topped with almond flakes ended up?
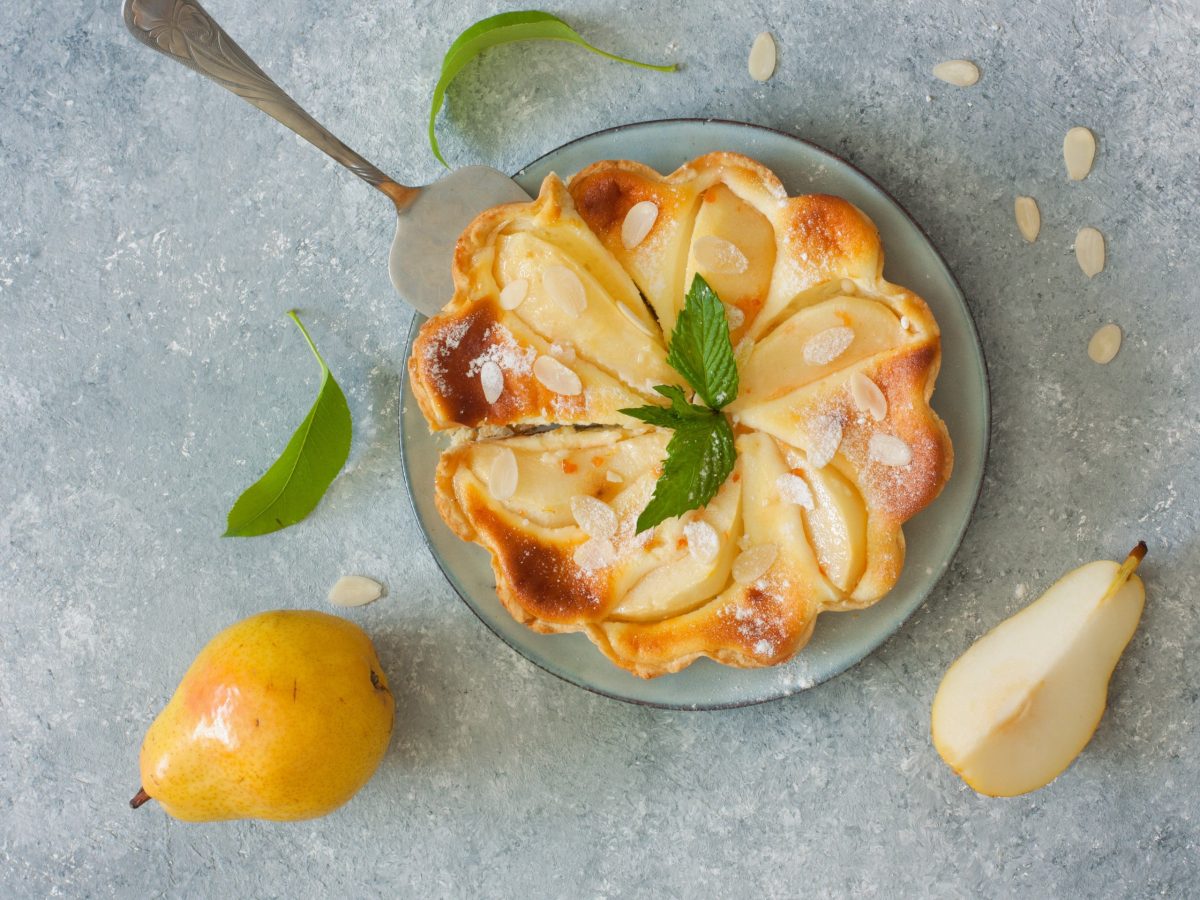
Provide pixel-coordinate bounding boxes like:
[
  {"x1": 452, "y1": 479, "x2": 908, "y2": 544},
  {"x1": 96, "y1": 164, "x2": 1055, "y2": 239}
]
[{"x1": 409, "y1": 154, "x2": 953, "y2": 678}]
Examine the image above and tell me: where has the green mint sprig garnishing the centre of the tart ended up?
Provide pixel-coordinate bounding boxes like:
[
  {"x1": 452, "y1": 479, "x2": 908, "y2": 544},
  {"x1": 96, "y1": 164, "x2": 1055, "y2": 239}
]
[{"x1": 620, "y1": 275, "x2": 738, "y2": 533}]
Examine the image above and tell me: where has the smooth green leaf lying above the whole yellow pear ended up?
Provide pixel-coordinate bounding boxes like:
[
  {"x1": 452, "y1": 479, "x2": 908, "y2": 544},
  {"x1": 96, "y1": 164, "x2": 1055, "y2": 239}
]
[{"x1": 224, "y1": 310, "x2": 353, "y2": 538}]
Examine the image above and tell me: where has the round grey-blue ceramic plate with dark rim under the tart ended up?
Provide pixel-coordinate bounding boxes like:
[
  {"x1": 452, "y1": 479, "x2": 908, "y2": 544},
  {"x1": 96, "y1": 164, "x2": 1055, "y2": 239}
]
[{"x1": 401, "y1": 120, "x2": 989, "y2": 709}]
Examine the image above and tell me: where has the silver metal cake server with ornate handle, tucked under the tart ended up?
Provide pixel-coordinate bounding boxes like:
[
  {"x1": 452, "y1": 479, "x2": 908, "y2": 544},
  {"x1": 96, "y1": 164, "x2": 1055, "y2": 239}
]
[{"x1": 125, "y1": 0, "x2": 529, "y2": 316}]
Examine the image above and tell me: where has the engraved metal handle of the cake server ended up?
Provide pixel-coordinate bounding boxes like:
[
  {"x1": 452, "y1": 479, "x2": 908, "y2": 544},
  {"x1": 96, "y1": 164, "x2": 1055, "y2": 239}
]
[{"x1": 125, "y1": 0, "x2": 420, "y2": 210}]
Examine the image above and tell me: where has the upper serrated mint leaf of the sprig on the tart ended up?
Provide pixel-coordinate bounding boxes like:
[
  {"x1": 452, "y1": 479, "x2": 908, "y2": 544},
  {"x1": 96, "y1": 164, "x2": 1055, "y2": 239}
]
[{"x1": 667, "y1": 275, "x2": 738, "y2": 409}]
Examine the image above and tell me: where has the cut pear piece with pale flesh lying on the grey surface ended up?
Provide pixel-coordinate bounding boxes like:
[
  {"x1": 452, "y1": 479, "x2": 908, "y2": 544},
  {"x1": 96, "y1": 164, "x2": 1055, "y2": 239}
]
[{"x1": 931, "y1": 544, "x2": 1146, "y2": 797}]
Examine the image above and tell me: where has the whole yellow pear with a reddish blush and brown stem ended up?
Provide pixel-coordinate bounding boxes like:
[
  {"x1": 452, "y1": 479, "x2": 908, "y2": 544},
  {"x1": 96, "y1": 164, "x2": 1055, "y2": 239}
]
[{"x1": 131, "y1": 610, "x2": 395, "y2": 822}]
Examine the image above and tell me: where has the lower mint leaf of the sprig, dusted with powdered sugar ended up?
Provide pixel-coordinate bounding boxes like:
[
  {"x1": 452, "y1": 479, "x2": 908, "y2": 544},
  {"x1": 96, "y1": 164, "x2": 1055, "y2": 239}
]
[{"x1": 637, "y1": 415, "x2": 737, "y2": 533}]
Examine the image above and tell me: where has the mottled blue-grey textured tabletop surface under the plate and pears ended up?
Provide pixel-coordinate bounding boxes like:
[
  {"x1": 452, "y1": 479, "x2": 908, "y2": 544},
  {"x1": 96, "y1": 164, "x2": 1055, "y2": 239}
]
[{"x1": 0, "y1": 0, "x2": 1200, "y2": 896}]
